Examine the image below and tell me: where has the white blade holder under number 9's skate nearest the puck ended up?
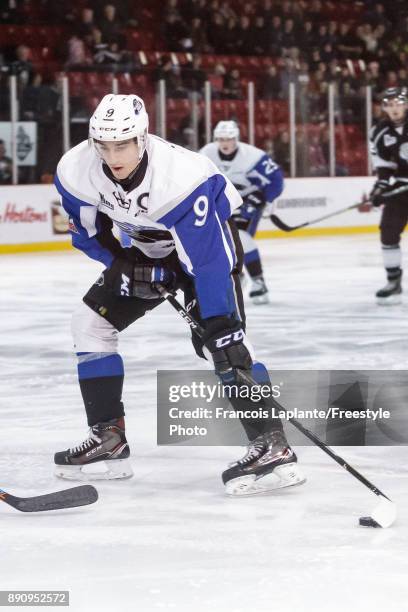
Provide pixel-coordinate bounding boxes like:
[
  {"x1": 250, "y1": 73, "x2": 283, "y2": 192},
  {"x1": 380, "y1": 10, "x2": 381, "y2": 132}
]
[{"x1": 225, "y1": 463, "x2": 306, "y2": 497}]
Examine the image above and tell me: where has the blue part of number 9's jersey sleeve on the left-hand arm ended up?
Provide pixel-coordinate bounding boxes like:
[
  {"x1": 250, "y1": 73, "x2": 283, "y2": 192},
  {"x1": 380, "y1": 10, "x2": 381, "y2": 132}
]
[{"x1": 54, "y1": 176, "x2": 113, "y2": 267}]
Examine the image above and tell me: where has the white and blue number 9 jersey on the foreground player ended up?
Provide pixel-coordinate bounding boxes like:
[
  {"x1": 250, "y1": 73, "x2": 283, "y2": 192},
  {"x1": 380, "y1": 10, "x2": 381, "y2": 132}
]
[{"x1": 55, "y1": 134, "x2": 242, "y2": 318}]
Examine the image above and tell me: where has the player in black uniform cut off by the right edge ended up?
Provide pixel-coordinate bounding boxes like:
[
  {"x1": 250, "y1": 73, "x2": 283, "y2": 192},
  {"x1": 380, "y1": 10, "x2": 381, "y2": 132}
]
[{"x1": 370, "y1": 87, "x2": 408, "y2": 304}]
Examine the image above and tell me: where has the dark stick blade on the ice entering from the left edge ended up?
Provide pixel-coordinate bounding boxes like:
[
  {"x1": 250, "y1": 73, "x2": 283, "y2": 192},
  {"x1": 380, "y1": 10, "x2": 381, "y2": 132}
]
[{"x1": 0, "y1": 485, "x2": 98, "y2": 512}]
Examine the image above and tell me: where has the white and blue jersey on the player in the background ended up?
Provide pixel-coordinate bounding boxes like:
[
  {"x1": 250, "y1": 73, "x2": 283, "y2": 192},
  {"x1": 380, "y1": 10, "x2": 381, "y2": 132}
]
[{"x1": 200, "y1": 142, "x2": 283, "y2": 203}]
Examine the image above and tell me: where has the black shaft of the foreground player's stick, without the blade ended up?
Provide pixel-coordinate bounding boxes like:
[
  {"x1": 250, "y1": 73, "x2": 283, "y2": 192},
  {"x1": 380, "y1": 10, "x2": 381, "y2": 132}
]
[{"x1": 158, "y1": 287, "x2": 390, "y2": 500}]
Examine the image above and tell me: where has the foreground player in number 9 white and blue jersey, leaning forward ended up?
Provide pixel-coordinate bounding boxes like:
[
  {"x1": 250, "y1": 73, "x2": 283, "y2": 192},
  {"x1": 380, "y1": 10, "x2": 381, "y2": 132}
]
[{"x1": 55, "y1": 95, "x2": 303, "y2": 494}]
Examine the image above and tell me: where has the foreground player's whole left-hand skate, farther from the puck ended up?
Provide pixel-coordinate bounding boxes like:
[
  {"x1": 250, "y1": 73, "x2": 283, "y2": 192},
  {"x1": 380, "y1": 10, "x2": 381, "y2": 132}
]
[{"x1": 54, "y1": 417, "x2": 133, "y2": 480}]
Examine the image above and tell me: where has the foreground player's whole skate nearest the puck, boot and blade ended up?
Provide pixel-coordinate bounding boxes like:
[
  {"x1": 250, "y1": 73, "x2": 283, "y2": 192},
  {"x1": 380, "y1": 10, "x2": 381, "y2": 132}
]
[{"x1": 222, "y1": 430, "x2": 306, "y2": 495}]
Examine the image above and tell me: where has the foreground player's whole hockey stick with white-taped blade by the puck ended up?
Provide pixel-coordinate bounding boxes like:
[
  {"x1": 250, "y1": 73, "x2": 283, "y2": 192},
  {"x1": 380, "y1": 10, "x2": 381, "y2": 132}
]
[{"x1": 157, "y1": 286, "x2": 397, "y2": 528}]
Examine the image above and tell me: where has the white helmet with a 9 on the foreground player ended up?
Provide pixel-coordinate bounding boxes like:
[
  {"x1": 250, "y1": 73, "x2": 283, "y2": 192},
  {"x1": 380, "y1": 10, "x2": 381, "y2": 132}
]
[{"x1": 89, "y1": 94, "x2": 149, "y2": 159}]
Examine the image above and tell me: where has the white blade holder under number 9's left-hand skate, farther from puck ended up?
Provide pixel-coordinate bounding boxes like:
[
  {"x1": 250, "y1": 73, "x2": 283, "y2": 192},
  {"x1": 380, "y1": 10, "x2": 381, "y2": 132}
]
[{"x1": 54, "y1": 459, "x2": 133, "y2": 482}]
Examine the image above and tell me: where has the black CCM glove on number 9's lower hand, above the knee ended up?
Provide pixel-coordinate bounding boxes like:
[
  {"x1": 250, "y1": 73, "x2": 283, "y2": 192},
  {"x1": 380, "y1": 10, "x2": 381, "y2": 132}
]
[{"x1": 203, "y1": 317, "x2": 252, "y2": 383}]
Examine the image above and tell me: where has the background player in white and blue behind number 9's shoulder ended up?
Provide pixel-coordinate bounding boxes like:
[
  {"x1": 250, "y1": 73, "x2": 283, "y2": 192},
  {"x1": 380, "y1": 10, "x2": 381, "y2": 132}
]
[{"x1": 200, "y1": 121, "x2": 283, "y2": 304}]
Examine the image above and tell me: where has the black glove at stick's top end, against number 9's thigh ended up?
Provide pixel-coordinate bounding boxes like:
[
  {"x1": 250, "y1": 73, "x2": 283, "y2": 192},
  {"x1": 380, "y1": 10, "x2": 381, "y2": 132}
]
[{"x1": 105, "y1": 258, "x2": 176, "y2": 300}]
